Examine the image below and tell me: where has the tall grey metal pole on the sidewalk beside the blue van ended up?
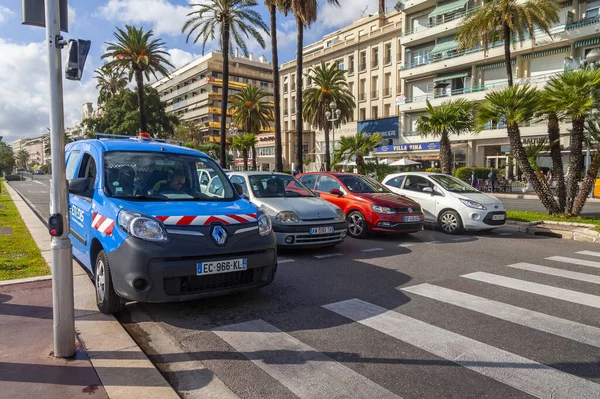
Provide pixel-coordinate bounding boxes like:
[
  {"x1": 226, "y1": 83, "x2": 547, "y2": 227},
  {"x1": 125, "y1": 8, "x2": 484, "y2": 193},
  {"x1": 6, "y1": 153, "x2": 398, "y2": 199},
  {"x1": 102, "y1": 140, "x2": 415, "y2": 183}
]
[{"x1": 45, "y1": 0, "x2": 75, "y2": 357}]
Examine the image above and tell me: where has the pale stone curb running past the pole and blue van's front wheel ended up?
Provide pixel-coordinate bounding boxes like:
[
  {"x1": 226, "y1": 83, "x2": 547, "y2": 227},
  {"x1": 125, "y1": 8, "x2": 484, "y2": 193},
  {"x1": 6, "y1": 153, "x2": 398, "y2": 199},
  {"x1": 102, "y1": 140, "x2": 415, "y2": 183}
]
[{"x1": 3, "y1": 184, "x2": 179, "y2": 399}]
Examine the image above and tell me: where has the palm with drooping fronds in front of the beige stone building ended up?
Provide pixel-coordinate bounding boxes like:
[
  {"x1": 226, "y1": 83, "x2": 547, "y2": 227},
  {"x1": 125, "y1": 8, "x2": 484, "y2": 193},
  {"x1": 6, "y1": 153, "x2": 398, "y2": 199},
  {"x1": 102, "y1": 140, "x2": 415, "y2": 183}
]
[{"x1": 302, "y1": 62, "x2": 356, "y2": 170}]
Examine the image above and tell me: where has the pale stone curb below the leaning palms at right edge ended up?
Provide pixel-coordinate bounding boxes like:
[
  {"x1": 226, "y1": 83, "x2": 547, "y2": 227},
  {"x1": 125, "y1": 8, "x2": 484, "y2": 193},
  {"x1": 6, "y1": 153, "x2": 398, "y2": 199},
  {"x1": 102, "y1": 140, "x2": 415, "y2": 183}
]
[{"x1": 504, "y1": 221, "x2": 600, "y2": 244}]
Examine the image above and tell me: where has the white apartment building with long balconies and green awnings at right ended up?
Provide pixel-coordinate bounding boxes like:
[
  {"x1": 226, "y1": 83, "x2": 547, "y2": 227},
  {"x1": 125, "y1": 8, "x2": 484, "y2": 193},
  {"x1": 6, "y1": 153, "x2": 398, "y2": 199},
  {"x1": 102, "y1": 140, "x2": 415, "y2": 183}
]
[{"x1": 394, "y1": 0, "x2": 600, "y2": 167}]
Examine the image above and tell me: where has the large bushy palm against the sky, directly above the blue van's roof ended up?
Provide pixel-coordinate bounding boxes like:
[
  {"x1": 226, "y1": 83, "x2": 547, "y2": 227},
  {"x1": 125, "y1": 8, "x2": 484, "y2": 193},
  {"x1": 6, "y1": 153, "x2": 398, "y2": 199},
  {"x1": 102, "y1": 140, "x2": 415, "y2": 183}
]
[{"x1": 102, "y1": 25, "x2": 175, "y2": 132}]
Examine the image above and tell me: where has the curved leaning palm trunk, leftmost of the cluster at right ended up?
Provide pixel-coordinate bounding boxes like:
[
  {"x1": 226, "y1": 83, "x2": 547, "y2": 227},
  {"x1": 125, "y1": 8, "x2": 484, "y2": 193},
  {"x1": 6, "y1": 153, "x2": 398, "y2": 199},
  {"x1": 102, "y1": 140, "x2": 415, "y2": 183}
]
[{"x1": 507, "y1": 124, "x2": 559, "y2": 215}]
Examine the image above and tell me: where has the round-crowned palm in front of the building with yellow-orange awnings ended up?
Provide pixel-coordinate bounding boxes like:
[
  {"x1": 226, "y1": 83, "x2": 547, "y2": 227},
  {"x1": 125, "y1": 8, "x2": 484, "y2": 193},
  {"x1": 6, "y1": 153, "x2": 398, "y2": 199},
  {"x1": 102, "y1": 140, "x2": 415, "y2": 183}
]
[{"x1": 229, "y1": 85, "x2": 273, "y2": 170}]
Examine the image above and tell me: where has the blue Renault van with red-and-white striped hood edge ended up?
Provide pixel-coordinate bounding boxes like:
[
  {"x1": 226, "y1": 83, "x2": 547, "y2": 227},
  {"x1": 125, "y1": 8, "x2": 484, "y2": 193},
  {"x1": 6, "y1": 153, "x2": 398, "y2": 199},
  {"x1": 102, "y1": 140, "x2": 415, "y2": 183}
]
[{"x1": 65, "y1": 133, "x2": 277, "y2": 313}]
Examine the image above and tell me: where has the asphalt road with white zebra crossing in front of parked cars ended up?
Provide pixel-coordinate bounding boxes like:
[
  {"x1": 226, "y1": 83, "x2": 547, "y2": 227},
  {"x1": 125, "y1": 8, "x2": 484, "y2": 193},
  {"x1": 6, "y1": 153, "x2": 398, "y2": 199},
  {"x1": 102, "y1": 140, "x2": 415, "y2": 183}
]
[{"x1": 8, "y1": 182, "x2": 600, "y2": 399}]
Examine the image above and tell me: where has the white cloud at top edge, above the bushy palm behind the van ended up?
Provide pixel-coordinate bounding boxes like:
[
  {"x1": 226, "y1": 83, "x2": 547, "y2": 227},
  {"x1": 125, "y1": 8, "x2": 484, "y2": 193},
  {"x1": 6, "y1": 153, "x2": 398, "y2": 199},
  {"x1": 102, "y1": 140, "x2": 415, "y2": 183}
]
[{"x1": 98, "y1": 0, "x2": 191, "y2": 36}]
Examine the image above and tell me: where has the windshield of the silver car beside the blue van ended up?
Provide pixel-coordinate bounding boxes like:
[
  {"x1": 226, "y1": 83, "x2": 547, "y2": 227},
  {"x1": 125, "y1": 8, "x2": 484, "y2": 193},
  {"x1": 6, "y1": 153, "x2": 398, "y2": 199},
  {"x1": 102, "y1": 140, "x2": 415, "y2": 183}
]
[{"x1": 249, "y1": 174, "x2": 315, "y2": 198}]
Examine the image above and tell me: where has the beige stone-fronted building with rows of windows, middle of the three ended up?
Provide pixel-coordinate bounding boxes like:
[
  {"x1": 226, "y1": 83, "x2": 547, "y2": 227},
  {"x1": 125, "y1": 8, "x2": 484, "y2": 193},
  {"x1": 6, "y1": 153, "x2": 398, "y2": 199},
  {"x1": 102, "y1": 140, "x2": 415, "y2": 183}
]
[{"x1": 279, "y1": 12, "x2": 403, "y2": 170}]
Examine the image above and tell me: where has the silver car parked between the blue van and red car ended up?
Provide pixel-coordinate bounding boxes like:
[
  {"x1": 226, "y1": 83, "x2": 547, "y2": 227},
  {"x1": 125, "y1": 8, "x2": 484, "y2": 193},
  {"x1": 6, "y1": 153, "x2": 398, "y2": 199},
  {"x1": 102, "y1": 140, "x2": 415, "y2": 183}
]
[{"x1": 228, "y1": 172, "x2": 348, "y2": 247}]
